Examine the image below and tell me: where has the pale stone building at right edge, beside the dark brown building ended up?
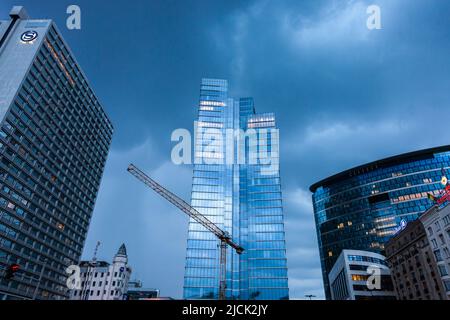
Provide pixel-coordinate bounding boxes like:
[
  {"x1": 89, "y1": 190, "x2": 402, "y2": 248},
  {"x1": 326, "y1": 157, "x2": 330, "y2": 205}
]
[{"x1": 420, "y1": 205, "x2": 450, "y2": 300}]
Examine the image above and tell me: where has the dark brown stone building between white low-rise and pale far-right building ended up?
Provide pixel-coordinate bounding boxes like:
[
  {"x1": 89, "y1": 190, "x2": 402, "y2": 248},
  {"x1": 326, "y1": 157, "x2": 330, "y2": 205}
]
[{"x1": 386, "y1": 219, "x2": 446, "y2": 300}]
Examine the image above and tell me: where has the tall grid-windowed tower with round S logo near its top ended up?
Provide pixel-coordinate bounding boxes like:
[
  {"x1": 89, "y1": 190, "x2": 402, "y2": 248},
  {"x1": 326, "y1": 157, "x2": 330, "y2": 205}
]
[{"x1": 0, "y1": 7, "x2": 113, "y2": 300}]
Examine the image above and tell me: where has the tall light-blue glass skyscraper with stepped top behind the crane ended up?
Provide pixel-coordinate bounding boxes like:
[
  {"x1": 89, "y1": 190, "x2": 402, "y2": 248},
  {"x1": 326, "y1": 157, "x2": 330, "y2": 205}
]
[{"x1": 184, "y1": 79, "x2": 289, "y2": 300}]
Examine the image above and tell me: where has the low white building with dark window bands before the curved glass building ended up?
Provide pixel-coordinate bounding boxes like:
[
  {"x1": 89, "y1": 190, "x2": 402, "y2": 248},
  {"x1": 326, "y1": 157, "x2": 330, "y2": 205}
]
[{"x1": 328, "y1": 250, "x2": 395, "y2": 300}]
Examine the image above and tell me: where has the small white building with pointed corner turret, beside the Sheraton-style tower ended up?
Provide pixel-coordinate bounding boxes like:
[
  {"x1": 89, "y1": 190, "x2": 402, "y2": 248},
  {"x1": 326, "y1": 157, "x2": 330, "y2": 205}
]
[{"x1": 70, "y1": 244, "x2": 131, "y2": 300}]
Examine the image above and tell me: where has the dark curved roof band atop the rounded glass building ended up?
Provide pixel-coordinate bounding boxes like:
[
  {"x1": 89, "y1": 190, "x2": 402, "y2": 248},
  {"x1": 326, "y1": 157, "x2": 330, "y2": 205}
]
[{"x1": 309, "y1": 145, "x2": 450, "y2": 192}]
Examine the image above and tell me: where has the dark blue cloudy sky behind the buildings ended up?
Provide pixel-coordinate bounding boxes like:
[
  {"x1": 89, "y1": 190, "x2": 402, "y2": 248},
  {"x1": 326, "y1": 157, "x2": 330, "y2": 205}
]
[{"x1": 0, "y1": 0, "x2": 450, "y2": 299}]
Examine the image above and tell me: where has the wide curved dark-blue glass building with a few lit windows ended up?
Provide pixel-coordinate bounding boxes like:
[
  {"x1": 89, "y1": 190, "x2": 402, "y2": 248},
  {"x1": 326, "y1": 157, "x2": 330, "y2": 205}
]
[{"x1": 310, "y1": 145, "x2": 450, "y2": 299}]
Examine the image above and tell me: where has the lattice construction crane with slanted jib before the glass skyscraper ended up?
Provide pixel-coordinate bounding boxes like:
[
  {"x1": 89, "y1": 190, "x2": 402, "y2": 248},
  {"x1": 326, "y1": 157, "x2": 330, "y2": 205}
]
[{"x1": 127, "y1": 164, "x2": 244, "y2": 300}]
